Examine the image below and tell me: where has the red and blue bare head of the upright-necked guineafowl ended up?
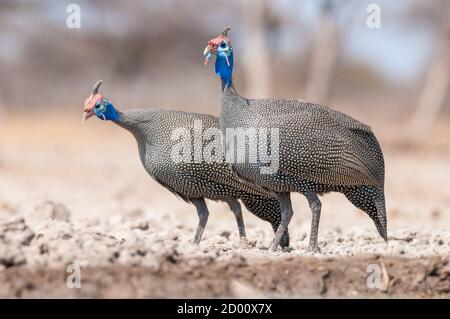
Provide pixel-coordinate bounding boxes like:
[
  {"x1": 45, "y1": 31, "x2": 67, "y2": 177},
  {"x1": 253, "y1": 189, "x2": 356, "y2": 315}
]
[{"x1": 203, "y1": 27, "x2": 233, "y2": 86}]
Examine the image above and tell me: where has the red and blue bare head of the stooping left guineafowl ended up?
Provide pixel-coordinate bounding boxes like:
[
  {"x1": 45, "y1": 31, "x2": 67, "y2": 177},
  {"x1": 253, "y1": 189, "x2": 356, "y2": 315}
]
[{"x1": 83, "y1": 81, "x2": 120, "y2": 123}]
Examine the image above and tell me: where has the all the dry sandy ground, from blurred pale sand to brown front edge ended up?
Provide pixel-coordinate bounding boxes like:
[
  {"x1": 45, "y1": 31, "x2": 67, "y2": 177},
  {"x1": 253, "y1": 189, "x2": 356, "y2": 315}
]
[{"x1": 0, "y1": 114, "x2": 450, "y2": 298}]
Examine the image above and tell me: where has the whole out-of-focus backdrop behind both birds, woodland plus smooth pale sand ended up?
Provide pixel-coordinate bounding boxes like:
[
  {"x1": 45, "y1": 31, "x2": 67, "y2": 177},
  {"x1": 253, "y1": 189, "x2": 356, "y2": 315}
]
[{"x1": 0, "y1": 0, "x2": 450, "y2": 235}]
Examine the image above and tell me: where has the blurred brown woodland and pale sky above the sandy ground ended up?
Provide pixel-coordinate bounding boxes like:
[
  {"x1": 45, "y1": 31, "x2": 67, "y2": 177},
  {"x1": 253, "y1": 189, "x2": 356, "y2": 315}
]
[{"x1": 0, "y1": 0, "x2": 450, "y2": 140}]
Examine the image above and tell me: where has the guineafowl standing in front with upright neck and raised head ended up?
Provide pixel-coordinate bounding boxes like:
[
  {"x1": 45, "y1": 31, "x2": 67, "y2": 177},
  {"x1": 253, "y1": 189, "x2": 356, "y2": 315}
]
[{"x1": 204, "y1": 27, "x2": 387, "y2": 252}]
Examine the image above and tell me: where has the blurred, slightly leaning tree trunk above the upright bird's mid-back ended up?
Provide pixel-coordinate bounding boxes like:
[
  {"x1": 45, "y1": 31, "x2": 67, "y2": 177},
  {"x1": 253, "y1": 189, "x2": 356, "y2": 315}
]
[{"x1": 306, "y1": 0, "x2": 339, "y2": 102}]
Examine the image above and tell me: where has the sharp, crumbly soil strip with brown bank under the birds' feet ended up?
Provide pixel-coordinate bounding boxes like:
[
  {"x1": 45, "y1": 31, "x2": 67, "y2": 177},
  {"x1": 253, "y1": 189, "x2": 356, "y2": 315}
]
[{"x1": 0, "y1": 212, "x2": 450, "y2": 298}]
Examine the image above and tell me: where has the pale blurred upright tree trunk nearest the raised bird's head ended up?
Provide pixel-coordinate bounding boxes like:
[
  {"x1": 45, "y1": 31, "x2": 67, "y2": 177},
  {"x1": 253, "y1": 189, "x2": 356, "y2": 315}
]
[{"x1": 242, "y1": 0, "x2": 271, "y2": 97}]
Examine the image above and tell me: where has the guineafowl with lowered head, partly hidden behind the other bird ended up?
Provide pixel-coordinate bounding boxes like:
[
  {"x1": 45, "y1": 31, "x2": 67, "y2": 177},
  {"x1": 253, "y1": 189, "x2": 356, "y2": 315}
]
[{"x1": 83, "y1": 81, "x2": 289, "y2": 248}]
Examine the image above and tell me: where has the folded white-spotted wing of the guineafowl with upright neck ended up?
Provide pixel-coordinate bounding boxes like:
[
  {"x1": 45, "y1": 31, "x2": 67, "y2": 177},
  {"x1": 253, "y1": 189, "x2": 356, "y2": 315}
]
[{"x1": 253, "y1": 101, "x2": 384, "y2": 188}]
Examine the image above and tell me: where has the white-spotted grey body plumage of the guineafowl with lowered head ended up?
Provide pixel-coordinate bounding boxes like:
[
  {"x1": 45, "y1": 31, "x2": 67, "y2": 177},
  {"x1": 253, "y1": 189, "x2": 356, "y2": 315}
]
[{"x1": 116, "y1": 109, "x2": 289, "y2": 247}]
